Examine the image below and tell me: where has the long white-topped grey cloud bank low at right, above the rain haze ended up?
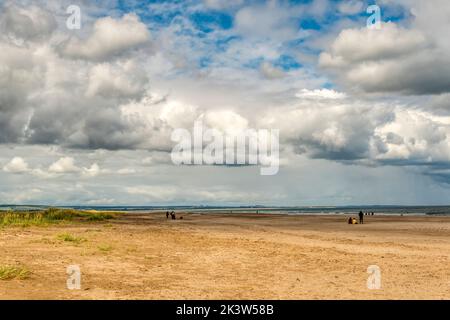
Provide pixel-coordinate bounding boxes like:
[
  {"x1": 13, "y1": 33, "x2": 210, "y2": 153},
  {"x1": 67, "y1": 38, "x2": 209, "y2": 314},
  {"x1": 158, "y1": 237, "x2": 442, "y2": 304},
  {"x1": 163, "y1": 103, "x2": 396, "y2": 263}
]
[{"x1": 259, "y1": 89, "x2": 450, "y2": 171}]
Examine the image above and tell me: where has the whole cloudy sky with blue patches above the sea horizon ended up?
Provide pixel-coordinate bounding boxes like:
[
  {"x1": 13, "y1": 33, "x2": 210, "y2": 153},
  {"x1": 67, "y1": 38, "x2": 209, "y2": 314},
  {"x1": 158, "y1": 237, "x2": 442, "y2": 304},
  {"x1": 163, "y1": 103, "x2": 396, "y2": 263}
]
[{"x1": 0, "y1": 0, "x2": 450, "y2": 206}]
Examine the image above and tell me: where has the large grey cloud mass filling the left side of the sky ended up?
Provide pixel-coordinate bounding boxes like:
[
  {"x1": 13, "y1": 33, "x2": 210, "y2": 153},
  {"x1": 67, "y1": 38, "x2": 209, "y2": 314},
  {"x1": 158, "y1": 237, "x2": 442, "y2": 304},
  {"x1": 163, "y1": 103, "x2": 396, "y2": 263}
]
[{"x1": 0, "y1": 3, "x2": 160, "y2": 149}]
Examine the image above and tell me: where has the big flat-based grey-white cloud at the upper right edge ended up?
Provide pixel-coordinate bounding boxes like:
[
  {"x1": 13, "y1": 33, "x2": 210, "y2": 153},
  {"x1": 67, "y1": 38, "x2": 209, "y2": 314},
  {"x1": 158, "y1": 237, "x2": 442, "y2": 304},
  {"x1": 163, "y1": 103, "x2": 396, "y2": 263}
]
[{"x1": 319, "y1": 22, "x2": 450, "y2": 95}]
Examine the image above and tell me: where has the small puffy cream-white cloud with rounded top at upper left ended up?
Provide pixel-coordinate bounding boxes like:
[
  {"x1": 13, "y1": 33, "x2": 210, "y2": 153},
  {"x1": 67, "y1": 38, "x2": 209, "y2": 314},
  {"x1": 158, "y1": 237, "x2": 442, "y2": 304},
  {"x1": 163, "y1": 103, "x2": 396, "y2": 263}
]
[{"x1": 63, "y1": 14, "x2": 150, "y2": 60}]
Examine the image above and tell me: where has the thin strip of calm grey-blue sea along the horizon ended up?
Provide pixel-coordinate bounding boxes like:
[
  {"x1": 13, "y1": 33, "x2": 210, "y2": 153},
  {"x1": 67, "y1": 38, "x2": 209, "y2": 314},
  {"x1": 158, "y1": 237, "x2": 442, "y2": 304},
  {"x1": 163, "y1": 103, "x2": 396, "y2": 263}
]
[{"x1": 0, "y1": 205, "x2": 450, "y2": 215}]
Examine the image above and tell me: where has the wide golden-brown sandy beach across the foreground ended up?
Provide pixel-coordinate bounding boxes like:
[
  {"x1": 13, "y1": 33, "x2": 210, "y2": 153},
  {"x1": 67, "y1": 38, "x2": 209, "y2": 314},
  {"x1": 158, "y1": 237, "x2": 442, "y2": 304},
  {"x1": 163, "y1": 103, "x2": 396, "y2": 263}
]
[{"x1": 0, "y1": 213, "x2": 450, "y2": 299}]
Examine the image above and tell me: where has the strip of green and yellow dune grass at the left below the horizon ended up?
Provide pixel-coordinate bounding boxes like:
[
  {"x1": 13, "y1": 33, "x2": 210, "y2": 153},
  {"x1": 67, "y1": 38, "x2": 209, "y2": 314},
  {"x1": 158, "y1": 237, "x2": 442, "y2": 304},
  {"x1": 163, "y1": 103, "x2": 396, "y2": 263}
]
[{"x1": 0, "y1": 208, "x2": 118, "y2": 227}]
